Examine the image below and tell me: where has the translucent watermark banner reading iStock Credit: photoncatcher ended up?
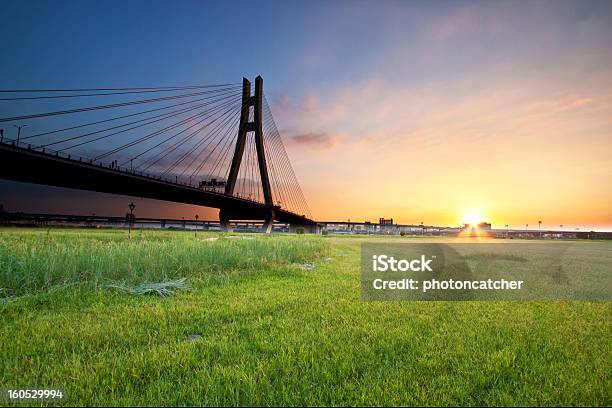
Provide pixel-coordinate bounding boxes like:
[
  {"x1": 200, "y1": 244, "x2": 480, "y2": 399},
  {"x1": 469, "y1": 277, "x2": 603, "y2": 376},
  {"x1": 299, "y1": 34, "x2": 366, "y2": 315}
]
[{"x1": 361, "y1": 241, "x2": 612, "y2": 301}]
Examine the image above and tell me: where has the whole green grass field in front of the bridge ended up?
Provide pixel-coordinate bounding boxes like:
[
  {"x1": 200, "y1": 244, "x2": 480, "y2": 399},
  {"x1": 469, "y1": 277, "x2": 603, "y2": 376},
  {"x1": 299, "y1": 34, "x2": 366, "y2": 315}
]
[{"x1": 0, "y1": 229, "x2": 612, "y2": 406}]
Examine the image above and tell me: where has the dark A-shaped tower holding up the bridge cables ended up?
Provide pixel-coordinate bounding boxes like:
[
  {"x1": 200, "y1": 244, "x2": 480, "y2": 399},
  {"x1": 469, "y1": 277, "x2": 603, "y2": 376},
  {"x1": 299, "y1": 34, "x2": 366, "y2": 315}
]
[{"x1": 219, "y1": 76, "x2": 275, "y2": 234}]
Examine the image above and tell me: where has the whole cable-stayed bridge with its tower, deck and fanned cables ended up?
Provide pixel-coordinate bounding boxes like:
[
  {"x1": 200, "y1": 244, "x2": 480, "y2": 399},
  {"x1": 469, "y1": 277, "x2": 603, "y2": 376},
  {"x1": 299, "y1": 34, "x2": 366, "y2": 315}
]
[{"x1": 0, "y1": 77, "x2": 317, "y2": 232}]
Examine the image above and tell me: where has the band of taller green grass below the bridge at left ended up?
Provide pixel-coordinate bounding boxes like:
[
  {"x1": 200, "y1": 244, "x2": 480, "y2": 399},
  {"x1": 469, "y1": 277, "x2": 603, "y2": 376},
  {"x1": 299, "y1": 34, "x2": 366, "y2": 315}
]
[{"x1": 0, "y1": 229, "x2": 328, "y2": 296}]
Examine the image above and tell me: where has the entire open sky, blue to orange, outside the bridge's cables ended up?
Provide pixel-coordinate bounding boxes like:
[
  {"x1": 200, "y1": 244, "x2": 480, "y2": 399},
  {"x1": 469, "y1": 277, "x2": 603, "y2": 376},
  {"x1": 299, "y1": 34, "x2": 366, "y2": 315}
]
[{"x1": 0, "y1": 1, "x2": 612, "y2": 225}]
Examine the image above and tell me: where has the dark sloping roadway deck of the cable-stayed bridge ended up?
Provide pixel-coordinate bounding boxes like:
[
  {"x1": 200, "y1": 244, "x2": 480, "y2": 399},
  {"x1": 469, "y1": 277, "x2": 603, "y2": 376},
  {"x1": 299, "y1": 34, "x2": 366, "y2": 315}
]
[{"x1": 0, "y1": 141, "x2": 317, "y2": 227}]
